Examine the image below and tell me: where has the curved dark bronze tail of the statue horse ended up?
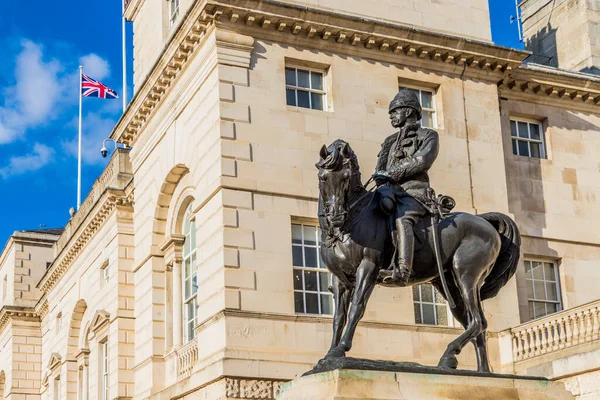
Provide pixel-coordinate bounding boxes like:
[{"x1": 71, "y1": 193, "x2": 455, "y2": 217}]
[{"x1": 479, "y1": 213, "x2": 521, "y2": 300}]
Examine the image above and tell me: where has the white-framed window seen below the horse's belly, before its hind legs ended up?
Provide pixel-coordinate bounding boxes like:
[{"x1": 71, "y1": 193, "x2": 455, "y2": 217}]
[{"x1": 412, "y1": 283, "x2": 449, "y2": 326}]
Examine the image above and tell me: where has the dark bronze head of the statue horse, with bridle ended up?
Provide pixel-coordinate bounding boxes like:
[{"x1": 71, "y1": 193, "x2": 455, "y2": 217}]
[{"x1": 316, "y1": 139, "x2": 363, "y2": 230}]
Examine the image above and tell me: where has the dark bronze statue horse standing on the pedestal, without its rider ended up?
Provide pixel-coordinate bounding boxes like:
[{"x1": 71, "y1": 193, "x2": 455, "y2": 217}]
[{"x1": 316, "y1": 140, "x2": 521, "y2": 372}]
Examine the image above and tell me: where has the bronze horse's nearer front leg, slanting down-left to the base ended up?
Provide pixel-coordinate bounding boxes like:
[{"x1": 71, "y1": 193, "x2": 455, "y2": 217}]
[{"x1": 338, "y1": 258, "x2": 379, "y2": 355}]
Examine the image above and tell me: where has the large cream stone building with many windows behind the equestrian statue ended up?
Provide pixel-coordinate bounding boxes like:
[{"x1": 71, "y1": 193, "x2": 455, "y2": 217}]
[{"x1": 0, "y1": 0, "x2": 600, "y2": 400}]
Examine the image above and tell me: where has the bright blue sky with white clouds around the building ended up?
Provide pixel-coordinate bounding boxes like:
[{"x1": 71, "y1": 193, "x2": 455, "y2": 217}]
[{"x1": 0, "y1": 0, "x2": 522, "y2": 242}]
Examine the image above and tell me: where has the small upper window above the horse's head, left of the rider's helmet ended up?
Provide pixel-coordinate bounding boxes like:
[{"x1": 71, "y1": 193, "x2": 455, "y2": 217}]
[{"x1": 285, "y1": 67, "x2": 327, "y2": 110}]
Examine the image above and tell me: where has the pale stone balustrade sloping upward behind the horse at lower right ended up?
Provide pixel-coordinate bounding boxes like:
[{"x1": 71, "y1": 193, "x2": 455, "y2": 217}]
[{"x1": 510, "y1": 300, "x2": 600, "y2": 362}]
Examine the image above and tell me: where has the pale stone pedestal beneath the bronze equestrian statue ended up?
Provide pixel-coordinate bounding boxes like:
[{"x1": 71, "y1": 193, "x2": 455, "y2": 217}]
[{"x1": 277, "y1": 369, "x2": 573, "y2": 400}]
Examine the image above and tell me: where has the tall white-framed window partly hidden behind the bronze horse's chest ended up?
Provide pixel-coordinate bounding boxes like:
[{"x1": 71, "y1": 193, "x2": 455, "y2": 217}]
[{"x1": 292, "y1": 224, "x2": 333, "y2": 315}]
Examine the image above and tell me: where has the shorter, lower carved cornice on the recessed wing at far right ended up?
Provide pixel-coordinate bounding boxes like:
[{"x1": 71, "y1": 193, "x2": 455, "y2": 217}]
[{"x1": 498, "y1": 65, "x2": 600, "y2": 112}]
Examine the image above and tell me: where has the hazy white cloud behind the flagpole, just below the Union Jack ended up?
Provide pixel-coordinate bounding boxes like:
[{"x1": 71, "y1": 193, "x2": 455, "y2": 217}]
[{"x1": 62, "y1": 113, "x2": 116, "y2": 165}]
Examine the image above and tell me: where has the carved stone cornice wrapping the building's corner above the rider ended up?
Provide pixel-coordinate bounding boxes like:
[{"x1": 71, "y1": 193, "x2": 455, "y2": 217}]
[{"x1": 111, "y1": 0, "x2": 529, "y2": 146}]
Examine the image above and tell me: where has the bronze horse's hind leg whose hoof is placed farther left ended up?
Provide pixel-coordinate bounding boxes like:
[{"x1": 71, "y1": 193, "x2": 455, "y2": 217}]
[{"x1": 438, "y1": 252, "x2": 488, "y2": 369}]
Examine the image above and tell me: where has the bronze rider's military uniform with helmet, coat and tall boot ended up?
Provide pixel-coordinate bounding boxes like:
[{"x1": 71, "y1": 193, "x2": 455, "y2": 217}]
[{"x1": 376, "y1": 90, "x2": 439, "y2": 280}]
